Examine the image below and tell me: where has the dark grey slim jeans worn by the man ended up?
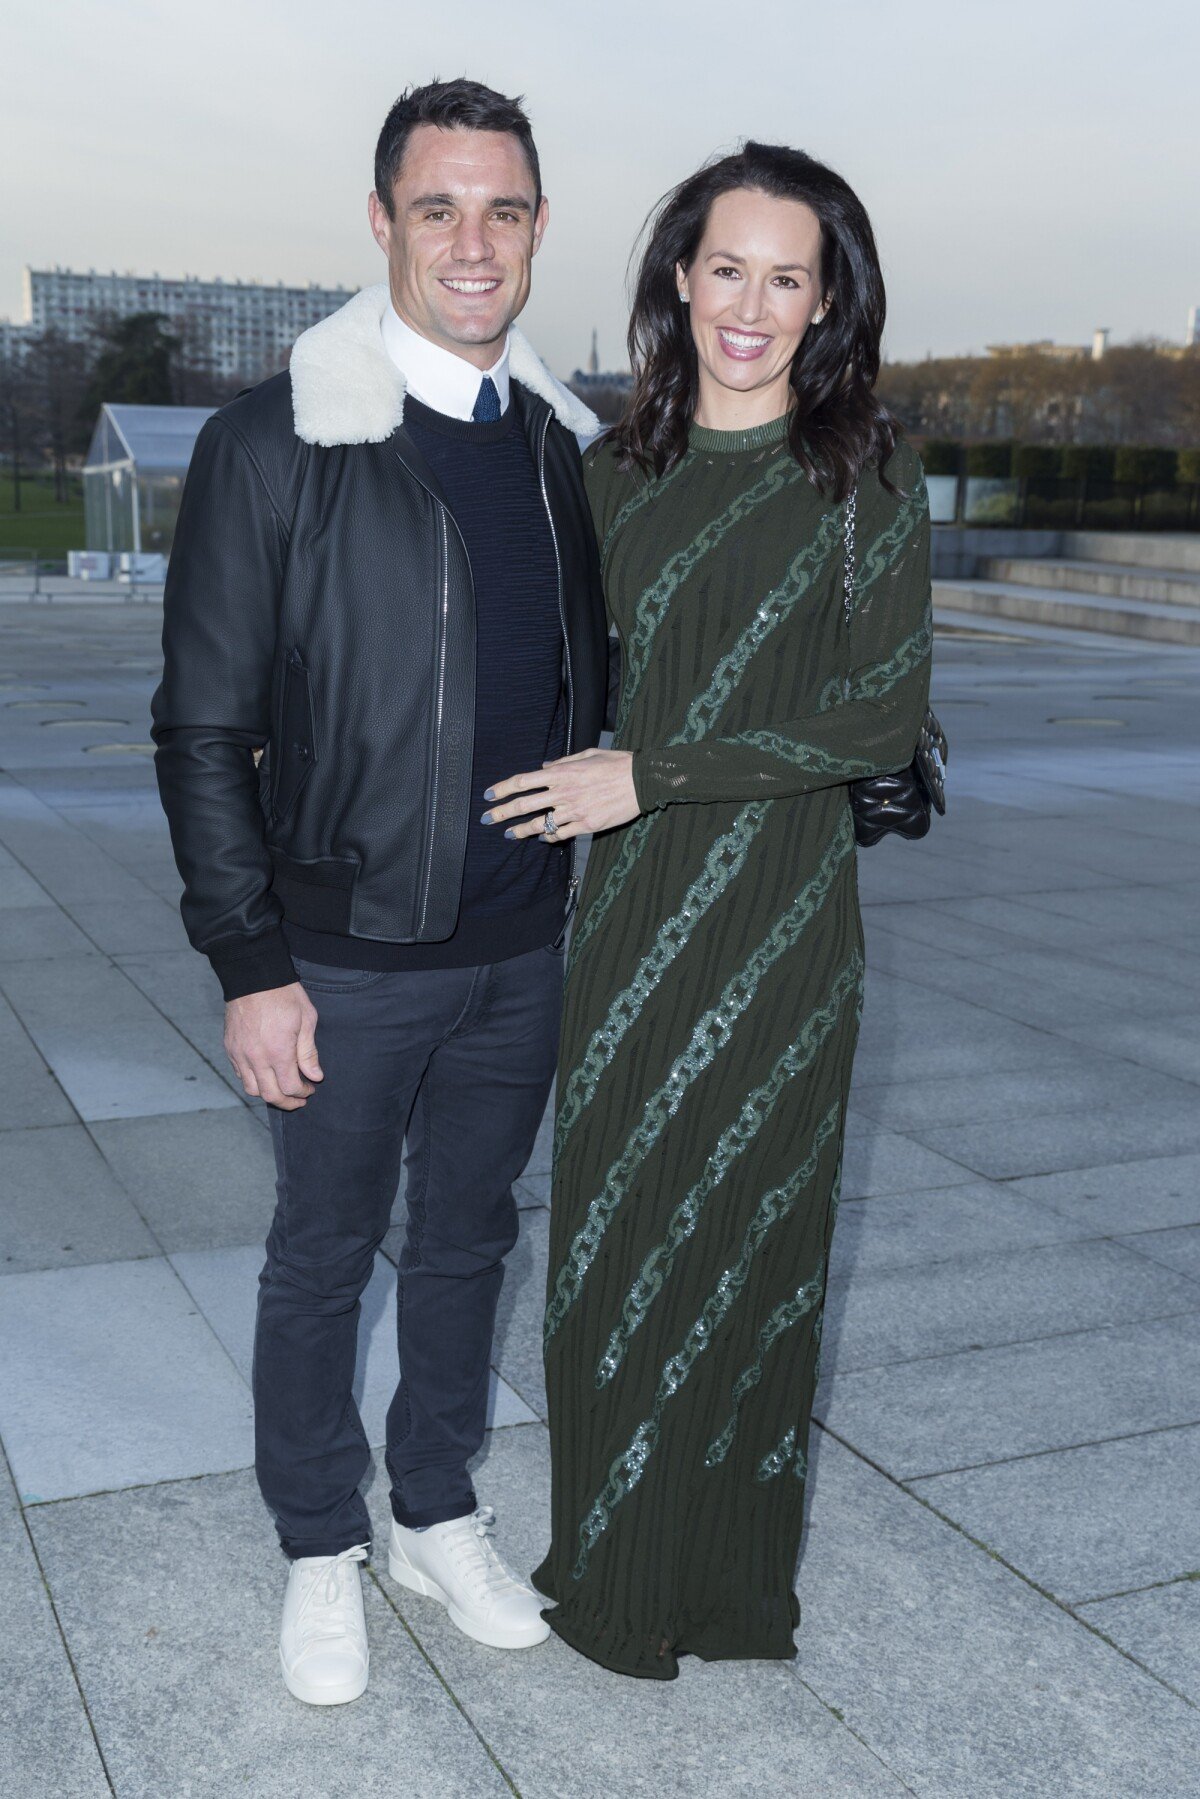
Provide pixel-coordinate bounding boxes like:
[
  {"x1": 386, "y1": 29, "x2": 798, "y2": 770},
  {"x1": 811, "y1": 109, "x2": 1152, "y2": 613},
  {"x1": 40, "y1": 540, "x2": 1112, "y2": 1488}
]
[{"x1": 254, "y1": 948, "x2": 563, "y2": 1558}]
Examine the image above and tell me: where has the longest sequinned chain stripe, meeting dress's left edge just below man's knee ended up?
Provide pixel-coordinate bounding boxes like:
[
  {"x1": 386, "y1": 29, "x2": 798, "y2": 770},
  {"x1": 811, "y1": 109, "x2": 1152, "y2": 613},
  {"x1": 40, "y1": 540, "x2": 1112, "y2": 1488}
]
[{"x1": 543, "y1": 811, "x2": 862, "y2": 1344}]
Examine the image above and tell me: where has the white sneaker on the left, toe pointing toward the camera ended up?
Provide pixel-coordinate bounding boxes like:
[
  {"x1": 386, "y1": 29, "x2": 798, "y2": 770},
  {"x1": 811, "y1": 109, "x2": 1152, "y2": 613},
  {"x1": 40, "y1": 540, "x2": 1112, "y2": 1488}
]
[{"x1": 279, "y1": 1544, "x2": 371, "y2": 1705}]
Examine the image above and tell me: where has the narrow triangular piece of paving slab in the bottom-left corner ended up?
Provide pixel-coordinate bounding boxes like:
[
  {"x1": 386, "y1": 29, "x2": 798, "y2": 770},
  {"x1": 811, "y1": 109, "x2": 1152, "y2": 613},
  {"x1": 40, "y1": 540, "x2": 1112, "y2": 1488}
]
[{"x1": 0, "y1": 1461, "x2": 110, "y2": 1799}]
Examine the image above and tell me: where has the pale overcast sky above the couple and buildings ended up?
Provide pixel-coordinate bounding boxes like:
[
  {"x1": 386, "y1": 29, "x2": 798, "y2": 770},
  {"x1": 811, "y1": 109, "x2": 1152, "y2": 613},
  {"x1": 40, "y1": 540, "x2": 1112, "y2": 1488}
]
[{"x1": 0, "y1": 0, "x2": 1200, "y2": 372}]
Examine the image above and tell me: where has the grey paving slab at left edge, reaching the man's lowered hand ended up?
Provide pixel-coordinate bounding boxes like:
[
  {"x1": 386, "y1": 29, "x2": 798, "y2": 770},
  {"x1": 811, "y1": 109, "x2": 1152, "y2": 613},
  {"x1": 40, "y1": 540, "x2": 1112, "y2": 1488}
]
[{"x1": 0, "y1": 957, "x2": 237, "y2": 1119}]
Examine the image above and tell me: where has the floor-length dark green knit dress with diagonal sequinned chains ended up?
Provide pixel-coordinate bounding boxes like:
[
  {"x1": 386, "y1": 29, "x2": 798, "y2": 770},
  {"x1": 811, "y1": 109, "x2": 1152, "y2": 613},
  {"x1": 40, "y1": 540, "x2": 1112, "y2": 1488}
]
[{"x1": 534, "y1": 419, "x2": 932, "y2": 1678}]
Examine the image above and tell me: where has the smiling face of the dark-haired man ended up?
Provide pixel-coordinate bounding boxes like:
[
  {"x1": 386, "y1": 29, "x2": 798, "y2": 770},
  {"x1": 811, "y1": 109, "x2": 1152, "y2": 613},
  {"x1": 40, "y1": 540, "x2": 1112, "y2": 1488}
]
[{"x1": 369, "y1": 124, "x2": 549, "y2": 369}]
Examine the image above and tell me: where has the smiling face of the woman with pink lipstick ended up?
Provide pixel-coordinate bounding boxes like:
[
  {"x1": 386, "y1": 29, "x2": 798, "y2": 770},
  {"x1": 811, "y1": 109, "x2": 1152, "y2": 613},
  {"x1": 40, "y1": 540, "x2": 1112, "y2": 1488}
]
[{"x1": 675, "y1": 187, "x2": 824, "y2": 412}]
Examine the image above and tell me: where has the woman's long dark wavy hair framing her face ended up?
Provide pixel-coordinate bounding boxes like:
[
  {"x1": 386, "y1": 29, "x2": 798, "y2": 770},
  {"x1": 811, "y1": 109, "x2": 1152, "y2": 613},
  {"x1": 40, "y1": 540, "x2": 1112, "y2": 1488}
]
[{"x1": 612, "y1": 142, "x2": 900, "y2": 500}]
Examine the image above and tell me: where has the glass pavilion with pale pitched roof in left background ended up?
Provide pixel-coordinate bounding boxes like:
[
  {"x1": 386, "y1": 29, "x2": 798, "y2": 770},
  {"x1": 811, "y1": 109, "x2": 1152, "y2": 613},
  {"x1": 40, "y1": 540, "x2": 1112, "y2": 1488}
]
[{"x1": 83, "y1": 405, "x2": 214, "y2": 556}]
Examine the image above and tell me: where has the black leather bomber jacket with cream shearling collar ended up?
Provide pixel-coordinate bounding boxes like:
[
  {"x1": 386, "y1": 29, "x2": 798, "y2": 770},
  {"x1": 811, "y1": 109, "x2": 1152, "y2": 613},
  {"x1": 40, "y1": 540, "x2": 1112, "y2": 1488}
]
[{"x1": 151, "y1": 288, "x2": 608, "y2": 998}]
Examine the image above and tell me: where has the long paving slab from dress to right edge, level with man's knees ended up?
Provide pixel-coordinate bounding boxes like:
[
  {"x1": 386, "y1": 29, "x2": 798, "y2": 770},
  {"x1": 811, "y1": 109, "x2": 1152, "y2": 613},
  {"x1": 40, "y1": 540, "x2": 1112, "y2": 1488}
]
[{"x1": 826, "y1": 1240, "x2": 1200, "y2": 1371}]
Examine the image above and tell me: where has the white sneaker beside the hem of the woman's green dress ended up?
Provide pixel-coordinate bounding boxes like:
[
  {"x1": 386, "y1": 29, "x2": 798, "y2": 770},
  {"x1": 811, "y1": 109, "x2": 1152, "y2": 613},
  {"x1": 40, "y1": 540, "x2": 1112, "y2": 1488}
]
[{"x1": 387, "y1": 1506, "x2": 551, "y2": 1650}]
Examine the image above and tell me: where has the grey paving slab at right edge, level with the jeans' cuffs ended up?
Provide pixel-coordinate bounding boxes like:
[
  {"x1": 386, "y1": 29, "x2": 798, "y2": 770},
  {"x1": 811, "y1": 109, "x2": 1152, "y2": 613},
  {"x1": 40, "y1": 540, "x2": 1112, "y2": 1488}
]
[{"x1": 912, "y1": 1425, "x2": 1200, "y2": 1603}]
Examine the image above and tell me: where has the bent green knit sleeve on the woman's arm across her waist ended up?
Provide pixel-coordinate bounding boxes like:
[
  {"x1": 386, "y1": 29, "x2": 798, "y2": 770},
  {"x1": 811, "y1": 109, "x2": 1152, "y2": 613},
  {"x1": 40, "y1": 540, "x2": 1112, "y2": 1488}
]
[{"x1": 633, "y1": 444, "x2": 934, "y2": 811}]
